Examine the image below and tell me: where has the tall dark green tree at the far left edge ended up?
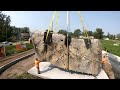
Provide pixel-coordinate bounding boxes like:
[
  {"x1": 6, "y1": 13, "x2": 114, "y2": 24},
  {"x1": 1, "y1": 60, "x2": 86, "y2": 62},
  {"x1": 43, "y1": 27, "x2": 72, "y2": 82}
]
[{"x1": 0, "y1": 12, "x2": 12, "y2": 41}]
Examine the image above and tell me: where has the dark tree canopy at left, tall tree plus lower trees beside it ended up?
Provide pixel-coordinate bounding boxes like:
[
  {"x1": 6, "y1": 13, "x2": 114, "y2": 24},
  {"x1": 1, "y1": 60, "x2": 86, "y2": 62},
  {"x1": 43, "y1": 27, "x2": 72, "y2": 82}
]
[{"x1": 0, "y1": 12, "x2": 29, "y2": 42}]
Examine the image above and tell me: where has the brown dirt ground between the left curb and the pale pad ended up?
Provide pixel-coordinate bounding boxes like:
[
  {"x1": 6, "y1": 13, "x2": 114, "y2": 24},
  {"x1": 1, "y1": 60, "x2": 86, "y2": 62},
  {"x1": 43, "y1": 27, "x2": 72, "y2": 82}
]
[{"x1": 0, "y1": 55, "x2": 35, "y2": 79}]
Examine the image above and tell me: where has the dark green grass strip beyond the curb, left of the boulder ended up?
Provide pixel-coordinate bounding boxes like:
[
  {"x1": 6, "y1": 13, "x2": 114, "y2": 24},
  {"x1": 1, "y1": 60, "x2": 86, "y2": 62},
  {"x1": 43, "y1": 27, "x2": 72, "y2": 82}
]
[{"x1": 5, "y1": 43, "x2": 33, "y2": 56}]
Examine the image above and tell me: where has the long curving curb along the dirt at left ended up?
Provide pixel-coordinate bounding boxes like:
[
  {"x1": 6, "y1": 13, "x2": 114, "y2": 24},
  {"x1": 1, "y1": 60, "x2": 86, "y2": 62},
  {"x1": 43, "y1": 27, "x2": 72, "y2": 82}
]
[{"x1": 0, "y1": 52, "x2": 35, "y2": 75}]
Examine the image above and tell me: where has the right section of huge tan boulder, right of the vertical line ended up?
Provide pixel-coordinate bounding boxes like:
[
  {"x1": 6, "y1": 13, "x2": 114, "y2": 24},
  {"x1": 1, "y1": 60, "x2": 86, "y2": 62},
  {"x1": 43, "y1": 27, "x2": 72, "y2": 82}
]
[{"x1": 69, "y1": 39, "x2": 102, "y2": 75}]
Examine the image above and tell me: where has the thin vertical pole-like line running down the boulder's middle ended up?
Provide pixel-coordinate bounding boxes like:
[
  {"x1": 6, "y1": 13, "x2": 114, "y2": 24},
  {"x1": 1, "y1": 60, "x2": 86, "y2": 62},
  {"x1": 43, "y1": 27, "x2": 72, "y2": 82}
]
[{"x1": 67, "y1": 11, "x2": 70, "y2": 70}]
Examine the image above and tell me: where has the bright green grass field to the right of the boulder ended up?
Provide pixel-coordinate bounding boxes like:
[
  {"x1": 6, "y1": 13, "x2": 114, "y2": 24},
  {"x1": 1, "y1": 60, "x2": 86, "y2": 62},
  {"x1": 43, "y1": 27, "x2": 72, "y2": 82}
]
[{"x1": 100, "y1": 40, "x2": 120, "y2": 56}]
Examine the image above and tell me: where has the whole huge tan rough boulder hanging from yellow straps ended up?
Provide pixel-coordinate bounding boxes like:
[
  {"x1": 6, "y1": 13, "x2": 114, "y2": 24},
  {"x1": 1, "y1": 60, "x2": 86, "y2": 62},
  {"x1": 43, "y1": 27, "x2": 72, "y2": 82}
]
[{"x1": 32, "y1": 33, "x2": 102, "y2": 75}]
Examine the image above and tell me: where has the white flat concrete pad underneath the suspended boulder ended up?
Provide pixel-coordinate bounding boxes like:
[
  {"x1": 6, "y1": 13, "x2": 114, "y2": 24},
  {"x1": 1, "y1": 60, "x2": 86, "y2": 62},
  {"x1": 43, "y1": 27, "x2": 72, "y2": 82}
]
[{"x1": 28, "y1": 62, "x2": 109, "y2": 79}]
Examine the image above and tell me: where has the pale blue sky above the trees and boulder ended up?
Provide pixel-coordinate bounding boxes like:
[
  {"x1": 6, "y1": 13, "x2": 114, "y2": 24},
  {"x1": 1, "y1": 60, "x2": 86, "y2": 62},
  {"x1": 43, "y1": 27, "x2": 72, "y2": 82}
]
[{"x1": 3, "y1": 11, "x2": 120, "y2": 34}]
